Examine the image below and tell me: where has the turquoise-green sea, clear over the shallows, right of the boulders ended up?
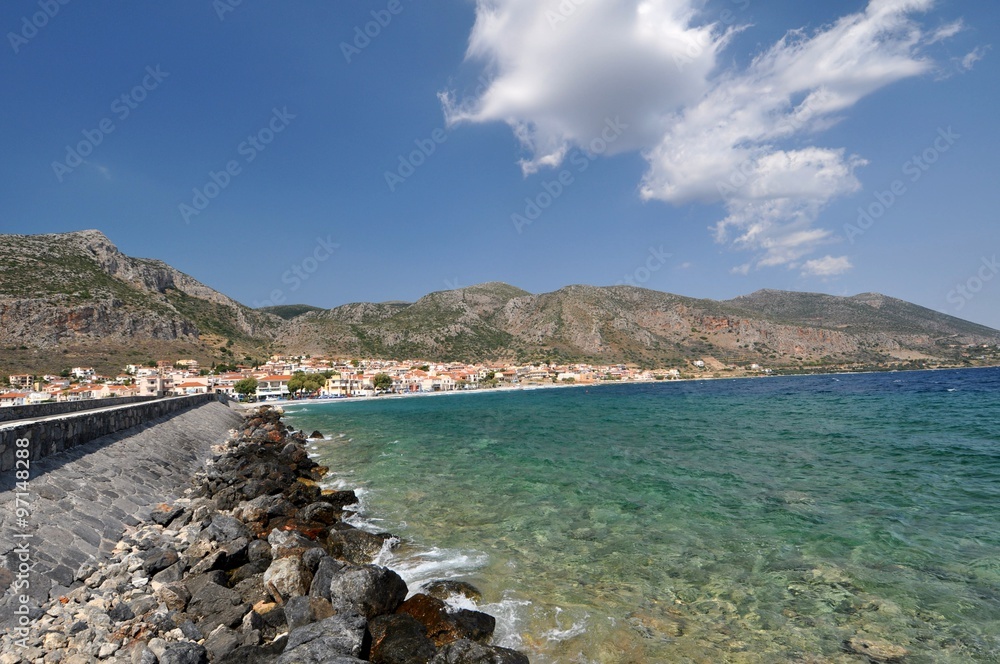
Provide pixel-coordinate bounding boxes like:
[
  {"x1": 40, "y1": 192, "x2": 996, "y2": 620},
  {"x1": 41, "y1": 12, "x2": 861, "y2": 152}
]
[{"x1": 287, "y1": 369, "x2": 1000, "y2": 663}]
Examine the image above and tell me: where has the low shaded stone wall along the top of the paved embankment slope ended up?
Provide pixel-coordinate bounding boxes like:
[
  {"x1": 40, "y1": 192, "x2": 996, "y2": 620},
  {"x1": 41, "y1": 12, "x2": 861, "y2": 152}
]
[{"x1": 0, "y1": 394, "x2": 218, "y2": 472}]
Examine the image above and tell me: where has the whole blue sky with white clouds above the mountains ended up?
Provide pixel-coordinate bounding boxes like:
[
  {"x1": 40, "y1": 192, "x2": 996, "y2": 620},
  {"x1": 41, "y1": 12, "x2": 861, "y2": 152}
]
[{"x1": 0, "y1": 0, "x2": 1000, "y2": 328}]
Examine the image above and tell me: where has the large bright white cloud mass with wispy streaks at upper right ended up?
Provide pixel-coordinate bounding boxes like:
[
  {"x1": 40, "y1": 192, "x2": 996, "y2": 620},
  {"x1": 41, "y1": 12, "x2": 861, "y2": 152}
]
[{"x1": 441, "y1": 0, "x2": 960, "y2": 276}]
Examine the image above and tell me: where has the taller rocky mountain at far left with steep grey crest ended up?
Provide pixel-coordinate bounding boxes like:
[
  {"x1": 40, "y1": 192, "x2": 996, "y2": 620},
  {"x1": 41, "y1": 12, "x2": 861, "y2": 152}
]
[{"x1": 0, "y1": 230, "x2": 283, "y2": 371}]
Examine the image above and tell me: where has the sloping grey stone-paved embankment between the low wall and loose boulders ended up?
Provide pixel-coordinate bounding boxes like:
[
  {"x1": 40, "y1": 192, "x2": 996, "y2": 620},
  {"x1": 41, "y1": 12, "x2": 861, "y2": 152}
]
[{"x1": 0, "y1": 402, "x2": 240, "y2": 629}]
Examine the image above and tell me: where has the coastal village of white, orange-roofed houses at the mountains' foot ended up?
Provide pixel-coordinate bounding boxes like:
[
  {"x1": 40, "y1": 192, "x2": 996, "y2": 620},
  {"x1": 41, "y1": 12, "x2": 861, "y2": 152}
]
[{"x1": 0, "y1": 356, "x2": 770, "y2": 407}]
